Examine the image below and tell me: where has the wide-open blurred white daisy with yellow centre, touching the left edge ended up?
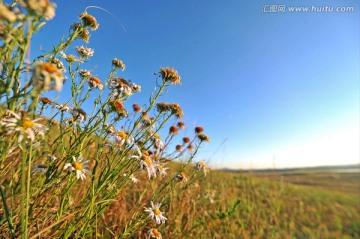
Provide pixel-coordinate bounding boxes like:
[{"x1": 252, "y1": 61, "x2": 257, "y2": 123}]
[{"x1": 0, "y1": 110, "x2": 48, "y2": 143}]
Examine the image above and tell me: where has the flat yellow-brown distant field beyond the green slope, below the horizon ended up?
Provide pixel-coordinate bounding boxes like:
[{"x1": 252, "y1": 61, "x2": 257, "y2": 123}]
[{"x1": 249, "y1": 170, "x2": 360, "y2": 195}]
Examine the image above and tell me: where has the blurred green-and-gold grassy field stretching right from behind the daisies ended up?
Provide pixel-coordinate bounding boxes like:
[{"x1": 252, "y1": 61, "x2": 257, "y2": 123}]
[{"x1": 97, "y1": 166, "x2": 360, "y2": 239}]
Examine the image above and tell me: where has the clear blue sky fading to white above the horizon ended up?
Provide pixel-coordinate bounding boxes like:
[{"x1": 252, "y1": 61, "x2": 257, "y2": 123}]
[{"x1": 27, "y1": 0, "x2": 360, "y2": 168}]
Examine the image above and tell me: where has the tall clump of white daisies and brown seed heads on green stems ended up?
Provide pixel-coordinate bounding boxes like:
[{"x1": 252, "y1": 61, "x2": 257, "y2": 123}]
[{"x1": 0, "y1": 3, "x2": 210, "y2": 238}]
